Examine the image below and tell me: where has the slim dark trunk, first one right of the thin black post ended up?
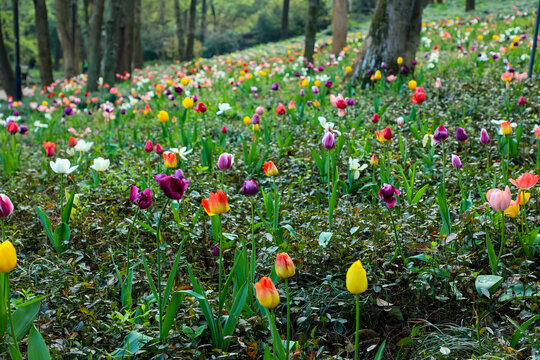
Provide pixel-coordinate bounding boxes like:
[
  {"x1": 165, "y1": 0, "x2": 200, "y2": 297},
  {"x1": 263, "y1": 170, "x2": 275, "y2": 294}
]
[{"x1": 34, "y1": 0, "x2": 54, "y2": 86}]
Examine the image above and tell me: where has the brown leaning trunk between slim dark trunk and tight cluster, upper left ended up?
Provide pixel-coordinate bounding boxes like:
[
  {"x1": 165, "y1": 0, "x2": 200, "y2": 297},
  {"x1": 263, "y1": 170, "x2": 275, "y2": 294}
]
[{"x1": 54, "y1": 0, "x2": 81, "y2": 78}]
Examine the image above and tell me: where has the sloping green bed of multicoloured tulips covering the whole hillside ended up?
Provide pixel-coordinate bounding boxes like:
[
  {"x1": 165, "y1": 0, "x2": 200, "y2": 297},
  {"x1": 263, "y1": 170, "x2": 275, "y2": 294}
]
[{"x1": 0, "y1": 5, "x2": 540, "y2": 359}]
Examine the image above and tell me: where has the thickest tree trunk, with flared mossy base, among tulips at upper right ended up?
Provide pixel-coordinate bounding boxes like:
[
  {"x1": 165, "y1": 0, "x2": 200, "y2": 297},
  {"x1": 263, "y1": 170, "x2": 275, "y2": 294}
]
[{"x1": 352, "y1": 0, "x2": 426, "y2": 82}]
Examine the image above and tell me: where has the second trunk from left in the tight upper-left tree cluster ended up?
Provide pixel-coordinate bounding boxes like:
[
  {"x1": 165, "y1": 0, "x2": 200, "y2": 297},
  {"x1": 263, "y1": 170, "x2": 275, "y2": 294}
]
[{"x1": 103, "y1": 0, "x2": 121, "y2": 85}]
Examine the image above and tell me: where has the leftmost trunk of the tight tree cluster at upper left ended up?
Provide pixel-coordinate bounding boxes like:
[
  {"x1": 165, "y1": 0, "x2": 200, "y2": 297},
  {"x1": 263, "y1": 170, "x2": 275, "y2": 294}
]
[{"x1": 87, "y1": 0, "x2": 105, "y2": 91}]
